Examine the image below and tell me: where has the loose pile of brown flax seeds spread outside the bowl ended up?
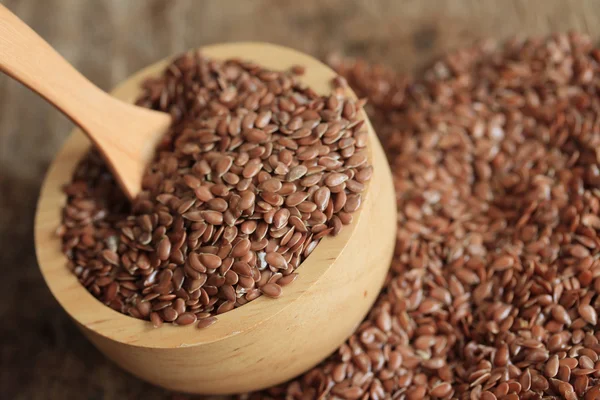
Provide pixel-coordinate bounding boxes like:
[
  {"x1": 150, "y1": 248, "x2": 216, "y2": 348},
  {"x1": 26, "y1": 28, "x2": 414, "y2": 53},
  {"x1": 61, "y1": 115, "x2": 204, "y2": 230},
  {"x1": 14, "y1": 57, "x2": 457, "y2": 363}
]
[{"x1": 241, "y1": 34, "x2": 600, "y2": 400}]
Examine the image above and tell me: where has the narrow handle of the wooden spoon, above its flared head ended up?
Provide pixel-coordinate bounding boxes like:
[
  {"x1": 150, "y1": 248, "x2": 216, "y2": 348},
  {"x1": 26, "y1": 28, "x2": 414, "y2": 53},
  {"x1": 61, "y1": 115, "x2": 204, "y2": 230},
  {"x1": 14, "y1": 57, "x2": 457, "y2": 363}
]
[{"x1": 0, "y1": 5, "x2": 109, "y2": 134}]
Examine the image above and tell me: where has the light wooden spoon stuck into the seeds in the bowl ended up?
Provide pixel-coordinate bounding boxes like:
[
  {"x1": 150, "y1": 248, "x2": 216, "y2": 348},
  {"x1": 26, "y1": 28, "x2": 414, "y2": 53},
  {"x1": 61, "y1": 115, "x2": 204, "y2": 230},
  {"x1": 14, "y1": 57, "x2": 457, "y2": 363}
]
[{"x1": 0, "y1": 5, "x2": 171, "y2": 199}]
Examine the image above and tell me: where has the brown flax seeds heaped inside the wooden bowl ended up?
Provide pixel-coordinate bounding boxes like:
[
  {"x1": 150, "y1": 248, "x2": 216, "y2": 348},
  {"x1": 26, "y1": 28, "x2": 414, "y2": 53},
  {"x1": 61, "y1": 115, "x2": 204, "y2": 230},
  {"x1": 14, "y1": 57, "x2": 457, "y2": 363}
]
[{"x1": 60, "y1": 52, "x2": 372, "y2": 328}]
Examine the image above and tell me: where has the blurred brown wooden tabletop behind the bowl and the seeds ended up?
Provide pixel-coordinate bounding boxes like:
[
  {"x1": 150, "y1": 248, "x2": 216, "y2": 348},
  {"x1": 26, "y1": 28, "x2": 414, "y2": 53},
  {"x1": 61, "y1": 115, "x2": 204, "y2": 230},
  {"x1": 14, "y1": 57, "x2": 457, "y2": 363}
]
[{"x1": 0, "y1": 0, "x2": 600, "y2": 400}]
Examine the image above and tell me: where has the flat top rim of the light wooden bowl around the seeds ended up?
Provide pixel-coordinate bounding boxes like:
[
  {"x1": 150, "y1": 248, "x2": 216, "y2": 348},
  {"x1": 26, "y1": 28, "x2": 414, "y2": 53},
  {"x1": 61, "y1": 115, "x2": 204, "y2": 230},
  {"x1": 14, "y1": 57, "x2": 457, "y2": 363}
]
[{"x1": 34, "y1": 42, "x2": 376, "y2": 349}]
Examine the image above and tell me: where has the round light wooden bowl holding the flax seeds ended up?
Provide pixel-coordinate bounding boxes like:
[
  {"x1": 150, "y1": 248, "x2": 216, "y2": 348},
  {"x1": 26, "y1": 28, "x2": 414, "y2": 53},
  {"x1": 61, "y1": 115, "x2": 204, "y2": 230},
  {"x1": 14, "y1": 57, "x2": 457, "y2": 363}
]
[{"x1": 35, "y1": 43, "x2": 396, "y2": 394}]
